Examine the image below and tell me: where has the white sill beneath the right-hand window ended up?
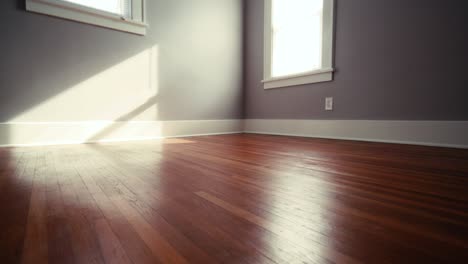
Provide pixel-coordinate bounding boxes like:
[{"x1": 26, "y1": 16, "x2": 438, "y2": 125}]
[{"x1": 262, "y1": 69, "x2": 334, "y2": 89}]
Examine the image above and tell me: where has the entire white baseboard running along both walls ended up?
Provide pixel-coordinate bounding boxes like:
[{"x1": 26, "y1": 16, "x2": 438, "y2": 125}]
[{"x1": 0, "y1": 119, "x2": 468, "y2": 148}]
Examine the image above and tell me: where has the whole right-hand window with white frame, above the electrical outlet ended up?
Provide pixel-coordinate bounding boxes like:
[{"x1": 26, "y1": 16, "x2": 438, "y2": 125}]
[{"x1": 263, "y1": 0, "x2": 333, "y2": 89}]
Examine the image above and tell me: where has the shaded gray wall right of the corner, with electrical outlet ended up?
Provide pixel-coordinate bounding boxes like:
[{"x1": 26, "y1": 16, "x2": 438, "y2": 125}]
[{"x1": 244, "y1": 0, "x2": 468, "y2": 120}]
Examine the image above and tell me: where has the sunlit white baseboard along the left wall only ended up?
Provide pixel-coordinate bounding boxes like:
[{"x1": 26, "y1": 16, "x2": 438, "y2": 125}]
[{"x1": 0, "y1": 119, "x2": 243, "y2": 147}]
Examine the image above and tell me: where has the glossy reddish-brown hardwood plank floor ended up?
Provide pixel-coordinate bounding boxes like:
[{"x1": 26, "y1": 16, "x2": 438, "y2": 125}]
[{"x1": 0, "y1": 134, "x2": 468, "y2": 264}]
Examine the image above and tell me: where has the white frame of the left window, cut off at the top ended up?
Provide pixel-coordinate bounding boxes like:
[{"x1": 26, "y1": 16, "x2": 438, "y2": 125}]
[{"x1": 25, "y1": 0, "x2": 148, "y2": 35}]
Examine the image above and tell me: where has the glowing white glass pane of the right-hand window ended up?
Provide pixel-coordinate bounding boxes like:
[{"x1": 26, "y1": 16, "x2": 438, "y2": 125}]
[{"x1": 271, "y1": 0, "x2": 323, "y2": 77}]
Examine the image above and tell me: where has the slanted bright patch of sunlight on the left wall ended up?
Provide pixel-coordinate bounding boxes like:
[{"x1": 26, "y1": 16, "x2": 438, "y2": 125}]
[{"x1": 9, "y1": 46, "x2": 158, "y2": 145}]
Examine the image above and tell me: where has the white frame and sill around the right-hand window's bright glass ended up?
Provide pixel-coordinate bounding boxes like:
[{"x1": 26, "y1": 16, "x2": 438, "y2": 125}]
[{"x1": 262, "y1": 0, "x2": 335, "y2": 89}]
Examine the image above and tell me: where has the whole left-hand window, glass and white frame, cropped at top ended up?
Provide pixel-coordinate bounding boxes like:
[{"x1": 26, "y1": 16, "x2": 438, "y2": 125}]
[{"x1": 26, "y1": 0, "x2": 147, "y2": 35}]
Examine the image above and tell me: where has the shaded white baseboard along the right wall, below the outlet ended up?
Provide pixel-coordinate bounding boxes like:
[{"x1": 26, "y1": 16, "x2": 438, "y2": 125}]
[{"x1": 244, "y1": 119, "x2": 468, "y2": 148}]
